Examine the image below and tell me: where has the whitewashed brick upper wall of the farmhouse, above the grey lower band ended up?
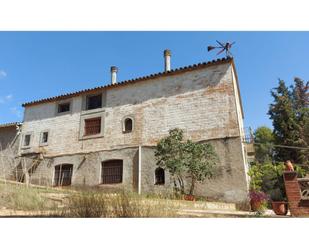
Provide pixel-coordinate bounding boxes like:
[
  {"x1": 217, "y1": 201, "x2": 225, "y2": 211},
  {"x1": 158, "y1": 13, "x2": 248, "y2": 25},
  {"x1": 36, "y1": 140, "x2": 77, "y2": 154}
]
[{"x1": 23, "y1": 63, "x2": 239, "y2": 155}]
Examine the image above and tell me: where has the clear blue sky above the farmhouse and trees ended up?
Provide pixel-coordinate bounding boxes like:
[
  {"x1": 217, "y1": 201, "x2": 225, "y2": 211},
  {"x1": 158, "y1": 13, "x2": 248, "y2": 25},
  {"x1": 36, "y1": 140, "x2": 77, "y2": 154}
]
[{"x1": 0, "y1": 31, "x2": 309, "y2": 128}]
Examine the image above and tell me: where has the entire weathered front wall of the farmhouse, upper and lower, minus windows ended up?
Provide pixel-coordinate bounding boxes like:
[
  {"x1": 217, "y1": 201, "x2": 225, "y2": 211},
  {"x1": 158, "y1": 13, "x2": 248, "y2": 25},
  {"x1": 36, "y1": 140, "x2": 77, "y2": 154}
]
[{"x1": 16, "y1": 59, "x2": 247, "y2": 201}]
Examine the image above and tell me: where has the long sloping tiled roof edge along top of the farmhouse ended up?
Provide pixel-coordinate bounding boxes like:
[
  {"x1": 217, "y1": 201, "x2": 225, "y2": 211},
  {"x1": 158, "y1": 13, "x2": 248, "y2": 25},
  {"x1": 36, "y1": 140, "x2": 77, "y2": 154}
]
[{"x1": 22, "y1": 57, "x2": 233, "y2": 107}]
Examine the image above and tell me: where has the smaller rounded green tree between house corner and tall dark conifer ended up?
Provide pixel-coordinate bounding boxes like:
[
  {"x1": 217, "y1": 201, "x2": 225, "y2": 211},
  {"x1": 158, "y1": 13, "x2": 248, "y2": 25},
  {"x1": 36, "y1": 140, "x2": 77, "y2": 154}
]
[{"x1": 254, "y1": 126, "x2": 274, "y2": 163}]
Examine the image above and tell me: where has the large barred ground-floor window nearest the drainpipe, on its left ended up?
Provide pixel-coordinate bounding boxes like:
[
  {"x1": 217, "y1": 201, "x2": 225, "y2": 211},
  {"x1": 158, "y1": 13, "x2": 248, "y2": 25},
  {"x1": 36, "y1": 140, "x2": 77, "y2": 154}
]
[{"x1": 102, "y1": 160, "x2": 123, "y2": 184}]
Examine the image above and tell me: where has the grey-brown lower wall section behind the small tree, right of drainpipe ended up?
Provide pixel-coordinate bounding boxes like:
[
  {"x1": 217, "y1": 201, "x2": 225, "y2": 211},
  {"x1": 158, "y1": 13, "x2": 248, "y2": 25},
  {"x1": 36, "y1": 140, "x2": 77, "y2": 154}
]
[{"x1": 142, "y1": 137, "x2": 248, "y2": 202}]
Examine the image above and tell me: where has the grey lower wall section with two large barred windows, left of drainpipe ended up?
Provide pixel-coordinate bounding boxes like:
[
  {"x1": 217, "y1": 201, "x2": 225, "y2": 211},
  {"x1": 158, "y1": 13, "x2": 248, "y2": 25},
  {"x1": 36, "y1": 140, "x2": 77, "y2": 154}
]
[{"x1": 30, "y1": 148, "x2": 138, "y2": 191}]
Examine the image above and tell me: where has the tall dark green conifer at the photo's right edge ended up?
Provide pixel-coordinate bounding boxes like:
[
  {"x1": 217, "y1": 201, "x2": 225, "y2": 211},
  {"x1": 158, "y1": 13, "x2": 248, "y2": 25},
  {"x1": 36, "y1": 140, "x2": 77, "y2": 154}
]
[{"x1": 268, "y1": 78, "x2": 309, "y2": 164}]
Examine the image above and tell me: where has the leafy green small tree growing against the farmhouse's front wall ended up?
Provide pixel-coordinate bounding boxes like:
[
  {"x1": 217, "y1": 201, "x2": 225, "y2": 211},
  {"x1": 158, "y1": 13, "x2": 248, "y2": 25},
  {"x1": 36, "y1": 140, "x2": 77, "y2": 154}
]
[{"x1": 155, "y1": 128, "x2": 218, "y2": 194}]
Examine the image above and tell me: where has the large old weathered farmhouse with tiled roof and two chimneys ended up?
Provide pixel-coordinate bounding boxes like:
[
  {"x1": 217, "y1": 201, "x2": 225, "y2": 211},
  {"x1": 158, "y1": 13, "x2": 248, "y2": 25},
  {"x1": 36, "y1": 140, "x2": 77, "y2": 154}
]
[{"x1": 0, "y1": 50, "x2": 248, "y2": 202}]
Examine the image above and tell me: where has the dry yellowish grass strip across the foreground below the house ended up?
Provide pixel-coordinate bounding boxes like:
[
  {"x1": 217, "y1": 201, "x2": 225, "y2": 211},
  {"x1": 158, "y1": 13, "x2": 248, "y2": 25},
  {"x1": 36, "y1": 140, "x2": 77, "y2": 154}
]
[{"x1": 0, "y1": 182, "x2": 262, "y2": 218}]
